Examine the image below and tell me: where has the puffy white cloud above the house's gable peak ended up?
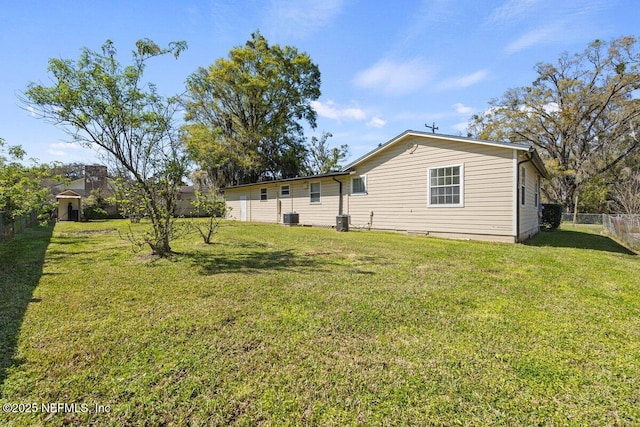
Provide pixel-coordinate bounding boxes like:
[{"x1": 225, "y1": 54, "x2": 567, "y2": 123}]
[{"x1": 353, "y1": 58, "x2": 432, "y2": 95}]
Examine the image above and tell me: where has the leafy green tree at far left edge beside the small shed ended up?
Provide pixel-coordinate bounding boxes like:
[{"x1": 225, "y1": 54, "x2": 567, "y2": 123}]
[{"x1": 0, "y1": 138, "x2": 53, "y2": 221}]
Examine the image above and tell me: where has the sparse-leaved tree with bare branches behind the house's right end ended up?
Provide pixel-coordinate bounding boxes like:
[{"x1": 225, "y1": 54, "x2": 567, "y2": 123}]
[{"x1": 469, "y1": 37, "x2": 640, "y2": 210}]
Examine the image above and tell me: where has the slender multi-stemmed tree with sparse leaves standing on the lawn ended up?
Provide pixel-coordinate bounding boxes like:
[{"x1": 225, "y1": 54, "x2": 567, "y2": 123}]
[{"x1": 23, "y1": 39, "x2": 187, "y2": 256}]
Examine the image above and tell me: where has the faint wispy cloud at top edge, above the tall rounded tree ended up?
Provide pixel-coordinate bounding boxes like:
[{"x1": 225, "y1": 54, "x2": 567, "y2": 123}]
[{"x1": 266, "y1": 0, "x2": 343, "y2": 38}]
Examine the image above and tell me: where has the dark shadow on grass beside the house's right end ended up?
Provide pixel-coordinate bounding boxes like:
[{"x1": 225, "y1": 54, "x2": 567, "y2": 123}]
[{"x1": 524, "y1": 229, "x2": 636, "y2": 255}]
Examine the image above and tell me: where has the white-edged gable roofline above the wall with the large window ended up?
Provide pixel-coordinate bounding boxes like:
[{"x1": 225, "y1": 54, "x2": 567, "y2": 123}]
[{"x1": 342, "y1": 130, "x2": 549, "y2": 178}]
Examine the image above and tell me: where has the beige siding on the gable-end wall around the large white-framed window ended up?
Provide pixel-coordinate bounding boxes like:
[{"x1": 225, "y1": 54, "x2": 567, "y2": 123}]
[{"x1": 345, "y1": 137, "x2": 514, "y2": 240}]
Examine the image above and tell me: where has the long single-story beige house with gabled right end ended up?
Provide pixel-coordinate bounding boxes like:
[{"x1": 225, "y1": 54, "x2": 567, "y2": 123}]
[{"x1": 223, "y1": 131, "x2": 547, "y2": 242}]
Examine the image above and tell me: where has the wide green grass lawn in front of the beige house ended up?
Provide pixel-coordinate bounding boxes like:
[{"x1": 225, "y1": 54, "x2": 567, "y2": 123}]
[{"x1": 0, "y1": 221, "x2": 640, "y2": 426}]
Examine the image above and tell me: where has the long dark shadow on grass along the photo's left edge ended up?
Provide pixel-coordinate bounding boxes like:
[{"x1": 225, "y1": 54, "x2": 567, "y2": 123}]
[{"x1": 0, "y1": 225, "x2": 53, "y2": 386}]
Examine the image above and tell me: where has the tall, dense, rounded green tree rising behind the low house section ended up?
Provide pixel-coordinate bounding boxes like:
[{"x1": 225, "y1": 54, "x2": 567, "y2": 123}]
[{"x1": 185, "y1": 32, "x2": 320, "y2": 186}]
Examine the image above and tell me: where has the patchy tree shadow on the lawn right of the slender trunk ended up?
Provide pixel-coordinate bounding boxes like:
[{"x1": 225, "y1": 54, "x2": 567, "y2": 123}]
[{"x1": 181, "y1": 249, "x2": 337, "y2": 275}]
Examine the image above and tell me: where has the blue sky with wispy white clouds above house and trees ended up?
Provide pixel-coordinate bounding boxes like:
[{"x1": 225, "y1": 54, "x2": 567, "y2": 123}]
[{"x1": 0, "y1": 0, "x2": 640, "y2": 163}]
